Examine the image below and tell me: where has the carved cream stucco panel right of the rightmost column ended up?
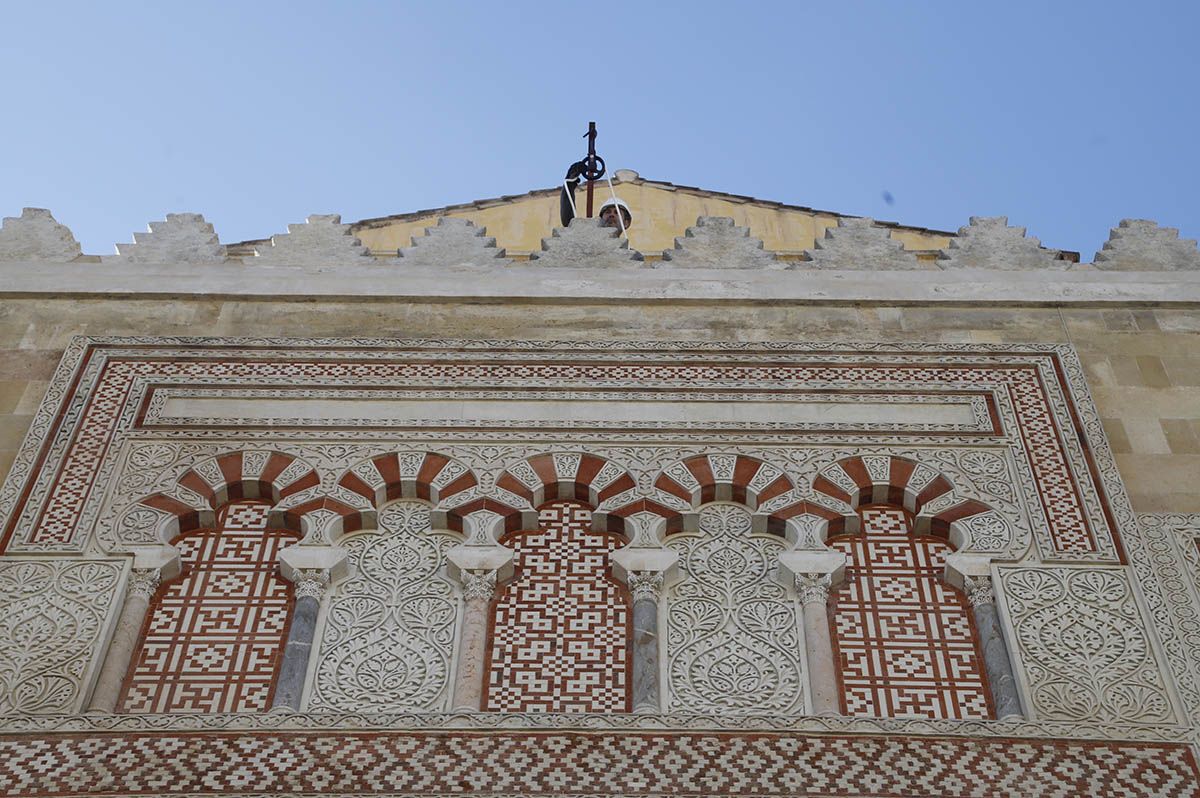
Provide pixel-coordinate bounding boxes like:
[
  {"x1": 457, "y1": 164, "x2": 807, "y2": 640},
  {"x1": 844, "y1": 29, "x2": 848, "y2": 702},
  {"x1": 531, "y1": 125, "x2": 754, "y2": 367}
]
[{"x1": 1000, "y1": 568, "x2": 1175, "y2": 722}]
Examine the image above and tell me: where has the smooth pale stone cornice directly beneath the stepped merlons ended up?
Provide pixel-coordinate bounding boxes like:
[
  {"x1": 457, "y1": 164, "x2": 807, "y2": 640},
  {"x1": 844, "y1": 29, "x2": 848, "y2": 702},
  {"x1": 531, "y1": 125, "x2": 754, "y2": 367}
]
[{"x1": 0, "y1": 258, "x2": 1200, "y2": 306}]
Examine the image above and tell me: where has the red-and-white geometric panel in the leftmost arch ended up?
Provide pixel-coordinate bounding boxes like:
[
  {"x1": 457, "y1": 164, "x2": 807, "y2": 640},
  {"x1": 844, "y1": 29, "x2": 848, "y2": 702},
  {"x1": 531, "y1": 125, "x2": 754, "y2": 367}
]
[{"x1": 118, "y1": 502, "x2": 299, "y2": 713}]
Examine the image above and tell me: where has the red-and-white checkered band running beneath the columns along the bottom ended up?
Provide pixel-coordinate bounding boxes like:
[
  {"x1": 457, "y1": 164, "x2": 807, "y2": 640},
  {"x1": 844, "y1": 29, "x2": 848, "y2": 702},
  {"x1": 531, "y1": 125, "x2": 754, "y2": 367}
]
[{"x1": 0, "y1": 731, "x2": 1200, "y2": 798}]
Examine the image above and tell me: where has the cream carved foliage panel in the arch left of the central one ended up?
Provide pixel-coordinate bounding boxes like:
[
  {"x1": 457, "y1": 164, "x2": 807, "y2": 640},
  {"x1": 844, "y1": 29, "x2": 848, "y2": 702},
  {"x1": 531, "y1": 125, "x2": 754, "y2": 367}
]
[{"x1": 308, "y1": 502, "x2": 460, "y2": 712}]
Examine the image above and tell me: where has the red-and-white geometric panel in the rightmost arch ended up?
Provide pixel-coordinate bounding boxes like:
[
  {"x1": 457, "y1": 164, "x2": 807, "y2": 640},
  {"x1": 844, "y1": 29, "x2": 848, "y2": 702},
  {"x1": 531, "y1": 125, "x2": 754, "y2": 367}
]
[{"x1": 829, "y1": 506, "x2": 992, "y2": 719}]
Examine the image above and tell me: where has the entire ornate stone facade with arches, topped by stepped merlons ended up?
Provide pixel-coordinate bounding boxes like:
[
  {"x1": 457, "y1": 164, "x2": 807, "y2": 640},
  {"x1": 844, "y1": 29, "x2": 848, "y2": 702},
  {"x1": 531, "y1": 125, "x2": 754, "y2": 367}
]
[{"x1": 0, "y1": 189, "x2": 1200, "y2": 796}]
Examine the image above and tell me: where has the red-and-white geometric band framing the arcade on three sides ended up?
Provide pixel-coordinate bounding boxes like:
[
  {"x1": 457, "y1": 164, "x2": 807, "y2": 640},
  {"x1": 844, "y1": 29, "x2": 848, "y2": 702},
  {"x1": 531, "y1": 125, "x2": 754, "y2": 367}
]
[{"x1": 16, "y1": 355, "x2": 1097, "y2": 554}]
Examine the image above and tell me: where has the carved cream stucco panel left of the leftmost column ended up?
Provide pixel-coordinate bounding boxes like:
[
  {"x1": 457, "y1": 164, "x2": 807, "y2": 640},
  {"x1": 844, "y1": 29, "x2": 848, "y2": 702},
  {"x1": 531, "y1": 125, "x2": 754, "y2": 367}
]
[{"x1": 0, "y1": 559, "x2": 122, "y2": 715}]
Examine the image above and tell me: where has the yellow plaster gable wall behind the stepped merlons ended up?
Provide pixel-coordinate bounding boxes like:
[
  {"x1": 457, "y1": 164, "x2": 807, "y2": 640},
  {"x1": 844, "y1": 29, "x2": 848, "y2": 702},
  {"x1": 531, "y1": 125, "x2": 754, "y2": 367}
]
[{"x1": 353, "y1": 180, "x2": 950, "y2": 256}]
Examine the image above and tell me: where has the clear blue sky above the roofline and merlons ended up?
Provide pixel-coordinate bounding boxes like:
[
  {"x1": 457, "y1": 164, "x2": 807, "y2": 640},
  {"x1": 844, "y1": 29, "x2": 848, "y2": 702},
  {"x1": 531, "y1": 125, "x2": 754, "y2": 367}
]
[{"x1": 0, "y1": 0, "x2": 1200, "y2": 255}]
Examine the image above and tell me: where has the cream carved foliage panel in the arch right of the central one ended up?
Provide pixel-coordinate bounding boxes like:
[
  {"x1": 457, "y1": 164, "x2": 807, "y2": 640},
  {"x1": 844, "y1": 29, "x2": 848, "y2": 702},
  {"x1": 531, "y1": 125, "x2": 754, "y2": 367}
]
[{"x1": 666, "y1": 504, "x2": 804, "y2": 713}]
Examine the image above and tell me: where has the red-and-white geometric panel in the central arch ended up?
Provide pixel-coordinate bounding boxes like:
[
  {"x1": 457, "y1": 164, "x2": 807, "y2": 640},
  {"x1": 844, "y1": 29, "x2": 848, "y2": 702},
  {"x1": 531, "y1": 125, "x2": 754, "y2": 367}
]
[{"x1": 484, "y1": 502, "x2": 630, "y2": 712}]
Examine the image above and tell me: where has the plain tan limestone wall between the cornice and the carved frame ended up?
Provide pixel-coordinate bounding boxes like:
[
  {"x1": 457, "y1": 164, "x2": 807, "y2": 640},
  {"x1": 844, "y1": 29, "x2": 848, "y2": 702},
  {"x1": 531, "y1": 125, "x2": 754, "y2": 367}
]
[{"x1": 0, "y1": 296, "x2": 1200, "y2": 512}]
